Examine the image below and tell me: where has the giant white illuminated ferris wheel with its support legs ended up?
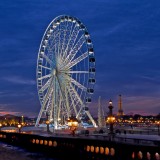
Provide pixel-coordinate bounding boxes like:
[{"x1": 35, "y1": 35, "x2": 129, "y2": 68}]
[{"x1": 36, "y1": 15, "x2": 96, "y2": 129}]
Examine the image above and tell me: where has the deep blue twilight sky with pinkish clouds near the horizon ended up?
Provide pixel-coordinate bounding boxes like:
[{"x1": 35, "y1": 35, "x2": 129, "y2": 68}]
[{"x1": 0, "y1": 0, "x2": 160, "y2": 116}]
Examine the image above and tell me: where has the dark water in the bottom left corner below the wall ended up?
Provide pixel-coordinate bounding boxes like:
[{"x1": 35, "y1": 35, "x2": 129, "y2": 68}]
[{"x1": 0, "y1": 142, "x2": 60, "y2": 160}]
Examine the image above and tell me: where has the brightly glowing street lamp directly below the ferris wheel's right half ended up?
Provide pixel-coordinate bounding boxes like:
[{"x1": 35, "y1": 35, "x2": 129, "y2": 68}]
[{"x1": 68, "y1": 115, "x2": 78, "y2": 136}]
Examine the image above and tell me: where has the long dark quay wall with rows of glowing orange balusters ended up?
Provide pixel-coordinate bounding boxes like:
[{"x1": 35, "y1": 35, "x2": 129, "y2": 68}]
[{"x1": 0, "y1": 132, "x2": 160, "y2": 160}]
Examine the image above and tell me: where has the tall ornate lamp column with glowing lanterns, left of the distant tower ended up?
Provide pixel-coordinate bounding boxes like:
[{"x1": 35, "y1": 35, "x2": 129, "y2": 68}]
[{"x1": 107, "y1": 100, "x2": 115, "y2": 135}]
